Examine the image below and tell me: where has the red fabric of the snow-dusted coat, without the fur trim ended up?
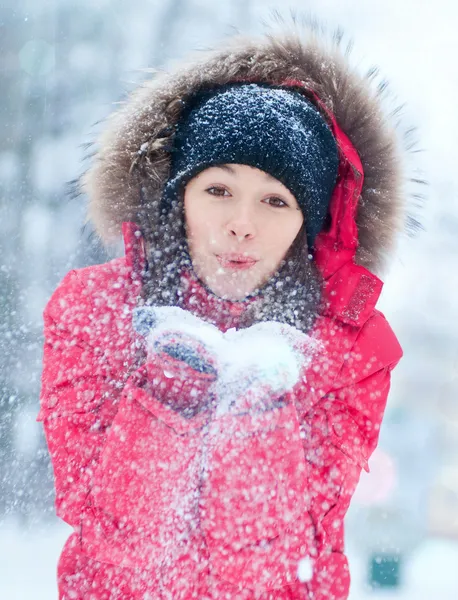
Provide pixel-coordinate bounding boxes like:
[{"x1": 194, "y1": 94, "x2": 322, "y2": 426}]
[{"x1": 38, "y1": 101, "x2": 402, "y2": 600}]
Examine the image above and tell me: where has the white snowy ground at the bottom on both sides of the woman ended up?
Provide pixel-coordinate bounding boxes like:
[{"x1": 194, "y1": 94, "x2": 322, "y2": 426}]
[{"x1": 0, "y1": 523, "x2": 458, "y2": 600}]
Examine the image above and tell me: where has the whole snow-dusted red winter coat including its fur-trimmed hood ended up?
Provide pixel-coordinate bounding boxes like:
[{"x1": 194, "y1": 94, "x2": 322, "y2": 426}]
[{"x1": 38, "y1": 22, "x2": 403, "y2": 600}]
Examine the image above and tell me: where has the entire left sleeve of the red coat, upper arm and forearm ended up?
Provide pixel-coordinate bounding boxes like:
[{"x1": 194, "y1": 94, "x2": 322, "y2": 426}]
[{"x1": 38, "y1": 272, "x2": 215, "y2": 569}]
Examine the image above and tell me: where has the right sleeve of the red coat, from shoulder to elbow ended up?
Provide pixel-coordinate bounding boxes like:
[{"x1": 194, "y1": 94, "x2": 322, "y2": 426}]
[{"x1": 298, "y1": 311, "x2": 402, "y2": 597}]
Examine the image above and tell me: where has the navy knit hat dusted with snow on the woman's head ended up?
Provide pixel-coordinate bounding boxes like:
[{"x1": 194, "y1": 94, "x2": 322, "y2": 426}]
[{"x1": 163, "y1": 83, "x2": 339, "y2": 248}]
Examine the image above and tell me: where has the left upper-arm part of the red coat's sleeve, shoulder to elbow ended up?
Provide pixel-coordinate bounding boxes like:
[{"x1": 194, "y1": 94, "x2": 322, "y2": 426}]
[{"x1": 37, "y1": 271, "x2": 131, "y2": 528}]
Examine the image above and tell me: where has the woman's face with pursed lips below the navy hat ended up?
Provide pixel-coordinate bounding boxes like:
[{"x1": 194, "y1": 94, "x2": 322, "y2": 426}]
[{"x1": 184, "y1": 164, "x2": 304, "y2": 300}]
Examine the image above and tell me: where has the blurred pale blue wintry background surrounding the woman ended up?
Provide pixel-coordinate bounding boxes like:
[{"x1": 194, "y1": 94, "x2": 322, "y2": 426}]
[{"x1": 0, "y1": 0, "x2": 458, "y2": 600}]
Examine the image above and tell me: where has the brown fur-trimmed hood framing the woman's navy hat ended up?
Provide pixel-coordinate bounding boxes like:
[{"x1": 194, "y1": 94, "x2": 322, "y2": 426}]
[{"x1": 80, "y1": 20, "x2": 422, "y2": 274}]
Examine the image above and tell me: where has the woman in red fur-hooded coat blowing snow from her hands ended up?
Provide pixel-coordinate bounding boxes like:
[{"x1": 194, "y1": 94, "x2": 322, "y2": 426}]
[{"x1": 39, "y1": 21, "x2": 404, "y2": 600}]
